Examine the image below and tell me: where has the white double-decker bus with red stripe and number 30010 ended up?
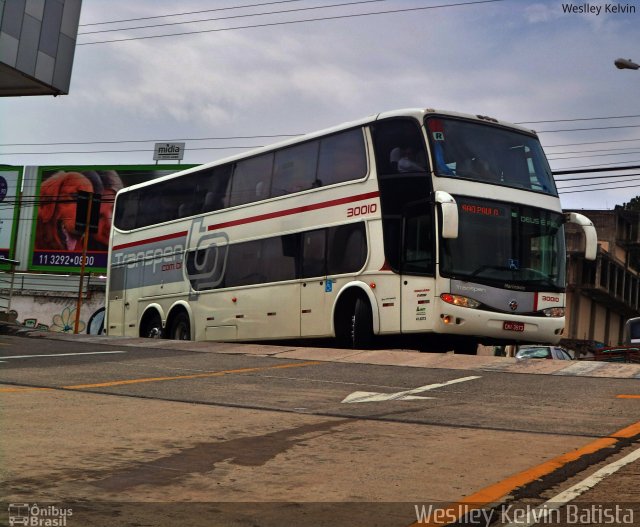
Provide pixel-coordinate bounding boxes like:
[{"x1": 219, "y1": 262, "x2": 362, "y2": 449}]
[{"x1": 106, "y1": 109, "x2": 596, "y2": 353}]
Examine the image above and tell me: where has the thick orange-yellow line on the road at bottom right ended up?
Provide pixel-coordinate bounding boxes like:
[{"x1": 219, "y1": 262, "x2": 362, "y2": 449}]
[{"x1": 411, "y1": 421, "x2": 640, "y2": 527}]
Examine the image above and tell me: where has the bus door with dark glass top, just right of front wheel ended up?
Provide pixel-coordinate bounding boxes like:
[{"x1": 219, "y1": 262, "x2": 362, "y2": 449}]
[{"x1": 401, "y1": 202, "x2": 435, "y2": 333}]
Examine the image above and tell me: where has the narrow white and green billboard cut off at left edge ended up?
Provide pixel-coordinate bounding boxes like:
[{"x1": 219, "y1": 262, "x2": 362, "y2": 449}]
[{"x1": 0, "y1": 166, "x2": 22, "y2": 271}]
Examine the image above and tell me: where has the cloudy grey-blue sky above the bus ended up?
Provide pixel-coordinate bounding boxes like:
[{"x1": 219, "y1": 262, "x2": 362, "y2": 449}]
[{"x1": 0, "y1": 0, "x2": 640, "y2": 209}]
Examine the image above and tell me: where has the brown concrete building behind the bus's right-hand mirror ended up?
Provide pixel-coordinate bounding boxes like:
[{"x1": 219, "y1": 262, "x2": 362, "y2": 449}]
[{"x1": 564, "y1": 206, "x2": 640, "y2": 347}]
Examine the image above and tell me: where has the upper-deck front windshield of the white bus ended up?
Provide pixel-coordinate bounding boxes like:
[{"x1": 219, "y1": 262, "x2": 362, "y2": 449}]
[{"x1": 426, "y1": 117, "x2": 558, "y2": 196}]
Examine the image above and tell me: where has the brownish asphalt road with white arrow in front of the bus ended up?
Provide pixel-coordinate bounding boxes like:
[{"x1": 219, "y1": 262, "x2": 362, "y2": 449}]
[{"x1": 0, "y1": 332, "x2": 640, "y2": 527}]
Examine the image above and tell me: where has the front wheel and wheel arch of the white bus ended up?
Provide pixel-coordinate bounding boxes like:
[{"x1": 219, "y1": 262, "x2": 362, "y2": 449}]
[{"x1": 332, "y1": 282, "x2": 380, "y2": 348}]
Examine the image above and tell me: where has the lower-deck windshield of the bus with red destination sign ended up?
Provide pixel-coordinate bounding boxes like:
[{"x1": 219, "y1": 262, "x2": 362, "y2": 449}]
[{"x1": 441, "y1": 196, "x2": 565, "y2": 291}]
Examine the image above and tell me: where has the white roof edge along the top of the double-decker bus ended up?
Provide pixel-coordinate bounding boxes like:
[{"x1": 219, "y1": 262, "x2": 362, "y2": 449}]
[{"x1": 119, "y1": 108, "x2": 536, "y2": 192}]
